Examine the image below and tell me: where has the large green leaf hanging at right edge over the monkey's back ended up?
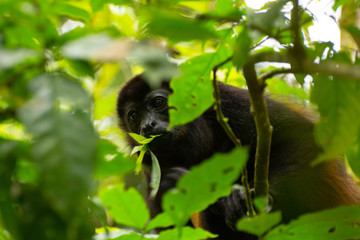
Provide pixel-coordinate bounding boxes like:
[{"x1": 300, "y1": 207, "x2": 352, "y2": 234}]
[{"x1": 311, "y1": 76, "x2": 360, "y2": 162}]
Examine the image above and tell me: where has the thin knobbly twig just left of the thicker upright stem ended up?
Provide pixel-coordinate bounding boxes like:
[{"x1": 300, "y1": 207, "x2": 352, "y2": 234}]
[{"x1": 213, "y1": 57, "x2": 256, "y2": 217}]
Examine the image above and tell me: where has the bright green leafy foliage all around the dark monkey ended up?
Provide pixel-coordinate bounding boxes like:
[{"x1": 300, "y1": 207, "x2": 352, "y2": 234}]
[{"x1": 0, "y1": 0, "x2": 360, "y2": 240}]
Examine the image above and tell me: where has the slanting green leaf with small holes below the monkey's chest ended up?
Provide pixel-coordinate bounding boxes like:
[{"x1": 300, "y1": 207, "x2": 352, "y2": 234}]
[{"x1": 162, "y1": 149, "x2": 247, "y2": 226}]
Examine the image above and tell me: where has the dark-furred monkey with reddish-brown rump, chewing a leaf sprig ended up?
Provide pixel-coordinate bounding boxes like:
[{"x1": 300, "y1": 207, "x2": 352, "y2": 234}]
[{"x1": 117, "y1": 75, "x2": 360, "y2": 240}]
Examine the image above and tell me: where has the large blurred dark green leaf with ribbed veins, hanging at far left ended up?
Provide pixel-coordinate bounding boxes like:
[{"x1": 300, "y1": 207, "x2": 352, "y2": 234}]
[{"x1": 19, "y1": 75, "x2": 97, "y2": 218}]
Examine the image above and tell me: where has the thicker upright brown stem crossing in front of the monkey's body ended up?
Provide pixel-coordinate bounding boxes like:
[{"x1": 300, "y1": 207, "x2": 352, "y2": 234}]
[{"x1": 243, "y1": 61, "x2": 272, "y2": 198}]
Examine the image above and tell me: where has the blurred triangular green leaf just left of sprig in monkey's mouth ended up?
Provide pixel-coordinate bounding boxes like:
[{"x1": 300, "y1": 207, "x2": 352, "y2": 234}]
[{"x1": 95, "y1": 139, "x2": 135, "y2": 179}]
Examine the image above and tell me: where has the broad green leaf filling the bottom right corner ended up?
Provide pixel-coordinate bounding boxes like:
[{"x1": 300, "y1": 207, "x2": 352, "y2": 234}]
[{"x1": 263, "y1": 206, "x2": 360, "y2": 240}]
